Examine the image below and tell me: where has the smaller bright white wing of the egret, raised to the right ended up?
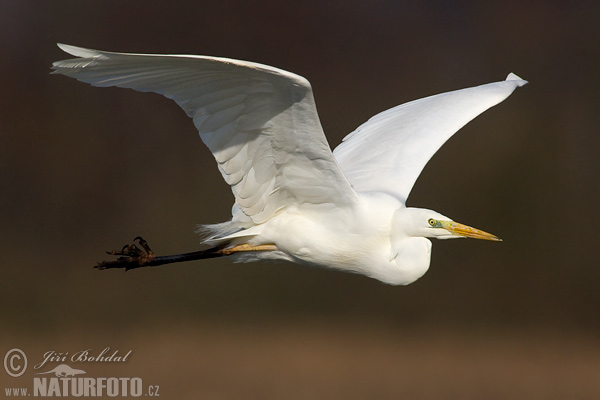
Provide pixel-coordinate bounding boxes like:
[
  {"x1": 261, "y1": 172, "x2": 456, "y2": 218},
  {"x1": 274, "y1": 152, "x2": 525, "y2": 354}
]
[{"x1": 333, "y1": 73, "x2": 527, "y2": 202}]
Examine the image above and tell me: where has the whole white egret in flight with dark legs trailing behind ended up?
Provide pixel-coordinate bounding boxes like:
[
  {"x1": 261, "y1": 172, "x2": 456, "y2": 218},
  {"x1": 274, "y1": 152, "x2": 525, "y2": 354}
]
[{"x1": 53, "y1": 44, "x2": 527, "y2": 285}]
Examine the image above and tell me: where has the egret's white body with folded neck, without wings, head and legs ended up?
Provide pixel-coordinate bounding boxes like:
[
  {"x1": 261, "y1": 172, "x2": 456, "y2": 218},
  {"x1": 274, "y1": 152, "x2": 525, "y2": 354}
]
[{"x1": 239, "y1": 193, "x2": 431, "y2": 284}]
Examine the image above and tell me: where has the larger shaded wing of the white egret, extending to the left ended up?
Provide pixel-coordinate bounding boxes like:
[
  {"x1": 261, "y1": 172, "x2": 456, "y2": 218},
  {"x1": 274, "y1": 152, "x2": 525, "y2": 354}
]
[{"x1": 53, "y1": 44, "x2": 356, "y2": 224}]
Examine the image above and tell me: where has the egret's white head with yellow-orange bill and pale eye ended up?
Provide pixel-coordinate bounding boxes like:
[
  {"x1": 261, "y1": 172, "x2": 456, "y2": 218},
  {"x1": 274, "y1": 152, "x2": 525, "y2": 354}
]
[{"x1": 401, "y1": 208, "x2": 502, "y2": 241}]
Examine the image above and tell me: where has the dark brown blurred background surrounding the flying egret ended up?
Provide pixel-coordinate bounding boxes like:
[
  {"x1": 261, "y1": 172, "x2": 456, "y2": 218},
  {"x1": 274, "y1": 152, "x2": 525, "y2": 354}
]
[{"x1": 0, "y1": 0, "x2": 600, "y2": 399}]
